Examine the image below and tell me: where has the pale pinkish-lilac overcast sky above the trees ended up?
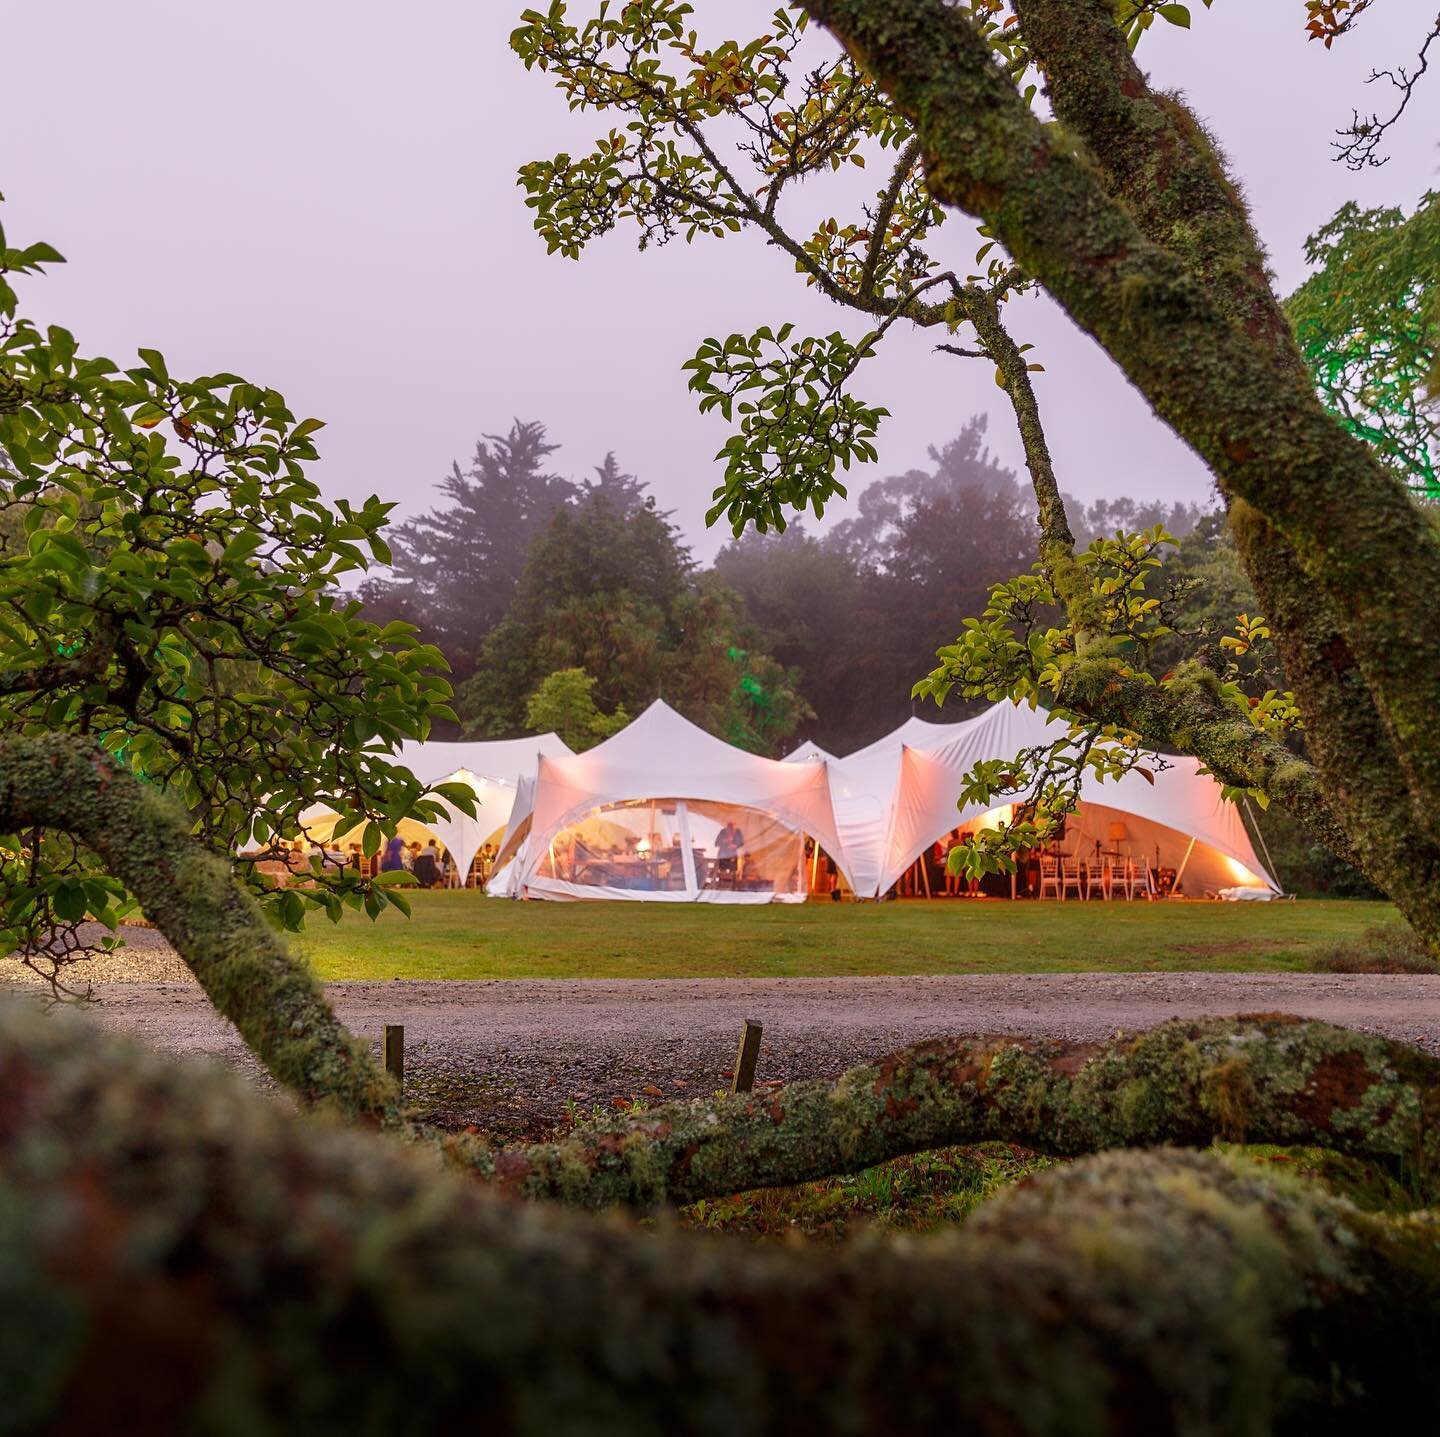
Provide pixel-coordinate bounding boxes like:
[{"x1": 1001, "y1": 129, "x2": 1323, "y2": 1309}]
[{"x1": 0, "y1": 0, "x2": 1440, "y2": 556}]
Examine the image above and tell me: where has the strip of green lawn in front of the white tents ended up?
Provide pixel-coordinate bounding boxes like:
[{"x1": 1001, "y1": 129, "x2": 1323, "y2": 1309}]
[{"x1": 298, "y1": 891, "x2": 1398, "y2": 979}]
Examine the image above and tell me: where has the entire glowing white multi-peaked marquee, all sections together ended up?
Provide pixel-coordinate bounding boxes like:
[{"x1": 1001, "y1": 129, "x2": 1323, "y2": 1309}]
[{"x1": 272, "y1": 701, "x2": 1279, "y2": 903}]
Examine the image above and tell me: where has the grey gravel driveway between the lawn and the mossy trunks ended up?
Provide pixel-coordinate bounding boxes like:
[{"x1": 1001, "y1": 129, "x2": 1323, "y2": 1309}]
[{"x1": 59, "y1": 973, "x2": 1440, "y2": 1132}]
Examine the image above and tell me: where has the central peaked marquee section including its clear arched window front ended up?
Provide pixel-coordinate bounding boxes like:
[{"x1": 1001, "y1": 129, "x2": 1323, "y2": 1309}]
[{"x1": 501, "y1": 700, "x2": 844, "y2": 903}]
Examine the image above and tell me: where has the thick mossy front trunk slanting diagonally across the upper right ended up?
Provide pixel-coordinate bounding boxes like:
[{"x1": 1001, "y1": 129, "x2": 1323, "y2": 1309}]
[{"x1": 805, "y1": 0, "x2": 1440, "y2": 844}]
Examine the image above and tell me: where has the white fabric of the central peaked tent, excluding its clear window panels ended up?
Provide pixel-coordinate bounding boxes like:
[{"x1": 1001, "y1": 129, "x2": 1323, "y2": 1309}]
[{"x1": 500, "y1": 700, "x2": 842, "y2": 903}]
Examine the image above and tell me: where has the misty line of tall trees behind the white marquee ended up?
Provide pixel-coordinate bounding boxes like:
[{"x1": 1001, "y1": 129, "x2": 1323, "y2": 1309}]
[{"x1": 361, "y1": 418, "x2": 1201, "y2": 754}]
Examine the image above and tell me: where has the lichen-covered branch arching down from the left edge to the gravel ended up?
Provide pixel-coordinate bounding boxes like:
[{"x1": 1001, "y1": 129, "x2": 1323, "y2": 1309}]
[{"x1": 0, "y1": 734, "x2": 399, "y2": 1123}]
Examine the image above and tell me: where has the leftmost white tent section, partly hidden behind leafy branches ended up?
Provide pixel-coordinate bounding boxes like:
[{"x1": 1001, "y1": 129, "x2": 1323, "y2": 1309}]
[{"x1": 301, "y1": 733, "x2": 572, "y2": 875}]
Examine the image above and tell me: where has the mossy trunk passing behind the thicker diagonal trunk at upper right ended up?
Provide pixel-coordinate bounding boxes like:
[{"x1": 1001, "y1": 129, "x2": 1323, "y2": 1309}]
[{"x1": 1018, "y1": 0, "x2": 1422, "y2": 933}]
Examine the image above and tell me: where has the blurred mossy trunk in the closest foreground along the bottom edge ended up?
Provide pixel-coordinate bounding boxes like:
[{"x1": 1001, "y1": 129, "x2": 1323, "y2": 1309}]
[{"x1": 0, "y1": 1002, "x2": 1440, "y2": 1437}]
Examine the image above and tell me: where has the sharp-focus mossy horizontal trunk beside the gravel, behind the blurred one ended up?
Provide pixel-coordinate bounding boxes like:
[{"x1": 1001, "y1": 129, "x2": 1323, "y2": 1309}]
[{"x1": 446, "y1": 1015, "x2": 1440, "y2": 1208}]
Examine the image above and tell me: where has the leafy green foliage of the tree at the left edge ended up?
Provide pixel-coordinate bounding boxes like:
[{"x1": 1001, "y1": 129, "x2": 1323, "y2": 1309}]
[{"x1": 0, "y1": 210, "x2": 468, "y2": 972}]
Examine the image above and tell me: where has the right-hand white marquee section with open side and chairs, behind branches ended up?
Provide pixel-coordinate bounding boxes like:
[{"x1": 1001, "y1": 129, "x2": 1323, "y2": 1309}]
[{"x1": 786, "y1": 701, "x2": 1277, "y2": 897}]
